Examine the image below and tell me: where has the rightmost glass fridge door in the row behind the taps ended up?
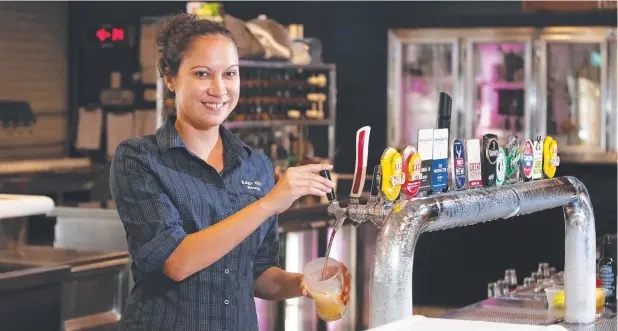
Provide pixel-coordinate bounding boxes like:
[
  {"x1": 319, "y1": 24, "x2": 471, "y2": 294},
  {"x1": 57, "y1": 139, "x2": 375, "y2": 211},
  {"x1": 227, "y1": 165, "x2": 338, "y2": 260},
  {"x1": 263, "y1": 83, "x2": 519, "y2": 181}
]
[{"x1": 538, "y1": 27, "x2": 616, "y2": 153}]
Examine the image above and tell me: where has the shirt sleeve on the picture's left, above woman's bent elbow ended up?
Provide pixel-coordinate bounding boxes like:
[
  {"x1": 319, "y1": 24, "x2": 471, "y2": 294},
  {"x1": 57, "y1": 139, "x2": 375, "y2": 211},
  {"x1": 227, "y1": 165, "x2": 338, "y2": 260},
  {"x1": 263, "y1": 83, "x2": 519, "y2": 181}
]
[{"x1": 110, "y1": 142, "x2": 187, "y2": 273}]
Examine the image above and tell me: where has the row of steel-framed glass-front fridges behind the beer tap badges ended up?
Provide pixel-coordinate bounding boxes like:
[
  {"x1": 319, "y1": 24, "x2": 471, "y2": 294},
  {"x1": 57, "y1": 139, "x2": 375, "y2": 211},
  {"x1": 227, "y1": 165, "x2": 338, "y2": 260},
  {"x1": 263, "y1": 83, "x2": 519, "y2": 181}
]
[{"x1": 387, "y1": 27, "x2": 618, "y2": 154}]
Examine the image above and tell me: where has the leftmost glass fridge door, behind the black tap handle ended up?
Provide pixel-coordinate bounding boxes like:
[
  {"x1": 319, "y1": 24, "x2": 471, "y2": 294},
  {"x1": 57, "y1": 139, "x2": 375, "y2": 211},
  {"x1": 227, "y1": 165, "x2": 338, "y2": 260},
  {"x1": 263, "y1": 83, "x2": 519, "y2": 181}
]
[{"x1": 387, "y1": 30, "x2": 461, "y2": 148}]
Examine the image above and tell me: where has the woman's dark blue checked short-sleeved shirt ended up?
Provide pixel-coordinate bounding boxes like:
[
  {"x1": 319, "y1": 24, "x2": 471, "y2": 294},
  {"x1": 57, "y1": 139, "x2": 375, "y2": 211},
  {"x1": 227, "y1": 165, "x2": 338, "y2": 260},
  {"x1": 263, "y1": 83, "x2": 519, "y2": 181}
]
[{"x1": 110, "y1": 120, "x2": 279, "y2": 331}]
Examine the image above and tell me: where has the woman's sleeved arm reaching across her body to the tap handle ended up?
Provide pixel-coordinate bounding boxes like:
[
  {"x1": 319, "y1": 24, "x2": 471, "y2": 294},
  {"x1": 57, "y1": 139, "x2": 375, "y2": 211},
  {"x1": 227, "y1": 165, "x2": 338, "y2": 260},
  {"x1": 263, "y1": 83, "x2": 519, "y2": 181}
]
[{"x1": 110, "y1": 141, "x2": 333, "y2": 281}]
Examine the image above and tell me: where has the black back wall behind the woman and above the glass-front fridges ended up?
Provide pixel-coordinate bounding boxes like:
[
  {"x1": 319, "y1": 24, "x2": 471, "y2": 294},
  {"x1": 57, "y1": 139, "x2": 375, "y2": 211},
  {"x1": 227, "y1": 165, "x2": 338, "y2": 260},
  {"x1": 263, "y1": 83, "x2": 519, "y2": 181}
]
[{"x1": 69, "y1": 1, "x2": 616, "y2": 173}]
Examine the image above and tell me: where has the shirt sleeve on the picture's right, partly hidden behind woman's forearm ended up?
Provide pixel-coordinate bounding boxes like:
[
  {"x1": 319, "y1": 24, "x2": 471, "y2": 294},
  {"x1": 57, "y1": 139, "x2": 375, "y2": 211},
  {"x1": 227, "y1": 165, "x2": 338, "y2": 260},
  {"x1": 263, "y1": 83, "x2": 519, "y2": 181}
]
[{"x1": 253, "y1": 156, "x2": 280, "y2": 280}]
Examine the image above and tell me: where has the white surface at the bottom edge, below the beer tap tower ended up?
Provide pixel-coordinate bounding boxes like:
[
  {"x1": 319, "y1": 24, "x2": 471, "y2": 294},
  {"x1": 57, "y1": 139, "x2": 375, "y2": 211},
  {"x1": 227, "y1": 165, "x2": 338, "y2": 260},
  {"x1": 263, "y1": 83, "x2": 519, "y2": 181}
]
[{"x1": 367, "y1": 315, "x2": 567, "y2": 331}]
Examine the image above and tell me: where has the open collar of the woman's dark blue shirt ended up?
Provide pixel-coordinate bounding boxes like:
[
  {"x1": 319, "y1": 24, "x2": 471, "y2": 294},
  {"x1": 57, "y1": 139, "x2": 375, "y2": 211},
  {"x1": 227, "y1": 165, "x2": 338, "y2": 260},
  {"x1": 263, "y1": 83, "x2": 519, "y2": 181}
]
[{"x1": 156, "y1": 116, "x2": 251, "y2": 164}]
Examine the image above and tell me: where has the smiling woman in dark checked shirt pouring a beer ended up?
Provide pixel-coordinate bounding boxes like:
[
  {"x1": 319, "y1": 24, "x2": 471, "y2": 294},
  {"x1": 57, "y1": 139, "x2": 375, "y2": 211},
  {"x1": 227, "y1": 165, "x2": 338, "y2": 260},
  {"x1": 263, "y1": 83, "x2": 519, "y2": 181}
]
[{"x1": 110, "y1": 14, "x2": 349, "y2": 331}]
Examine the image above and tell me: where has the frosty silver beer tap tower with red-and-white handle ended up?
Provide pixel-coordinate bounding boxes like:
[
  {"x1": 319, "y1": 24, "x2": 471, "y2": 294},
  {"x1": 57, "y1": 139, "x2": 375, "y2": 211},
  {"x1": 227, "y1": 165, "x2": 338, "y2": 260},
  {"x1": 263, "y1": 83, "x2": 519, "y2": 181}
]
[{"x1": 322, "y1": 127, "x2": 596, "y2": 328}]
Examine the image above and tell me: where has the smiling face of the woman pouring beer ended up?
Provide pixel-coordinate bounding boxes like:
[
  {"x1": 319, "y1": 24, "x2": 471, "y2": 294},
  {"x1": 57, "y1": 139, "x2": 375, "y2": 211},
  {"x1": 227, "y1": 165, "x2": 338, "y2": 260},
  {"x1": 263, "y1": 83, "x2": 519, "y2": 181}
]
[{"x1": 166, "y1": 35, "x2": 240, "y2": 130}]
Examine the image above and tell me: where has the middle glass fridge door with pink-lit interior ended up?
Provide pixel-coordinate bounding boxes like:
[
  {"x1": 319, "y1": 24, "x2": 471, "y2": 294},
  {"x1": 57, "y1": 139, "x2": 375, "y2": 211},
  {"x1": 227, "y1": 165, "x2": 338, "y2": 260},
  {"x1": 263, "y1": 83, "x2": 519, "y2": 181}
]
[{"x1": 461, "y1": 28, "x2": 534, "y2": 144}]
